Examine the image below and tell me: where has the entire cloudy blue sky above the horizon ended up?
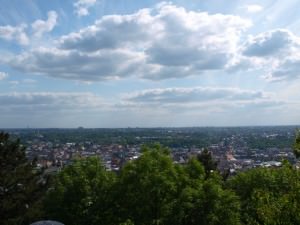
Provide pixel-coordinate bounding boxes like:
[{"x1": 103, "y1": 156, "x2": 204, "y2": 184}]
[{"x1": 0, "y1": 0, "x2": 300, "y2": 128}]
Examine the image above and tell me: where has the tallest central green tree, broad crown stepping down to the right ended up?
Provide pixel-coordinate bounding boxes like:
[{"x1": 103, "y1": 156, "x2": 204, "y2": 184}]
[{"x1": 118, "y1": 145, "x2": 240, "y2": 225}]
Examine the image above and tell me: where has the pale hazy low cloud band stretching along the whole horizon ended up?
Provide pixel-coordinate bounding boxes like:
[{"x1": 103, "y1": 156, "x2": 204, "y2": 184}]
[{"x1": 0, "y1": 87, "x2": 299, "y2": 127}]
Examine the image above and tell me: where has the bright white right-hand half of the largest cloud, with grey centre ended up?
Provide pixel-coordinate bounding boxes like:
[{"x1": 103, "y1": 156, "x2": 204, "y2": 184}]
[{"x1": 146, "y1": 5, "x2": 251, "y2": 71}]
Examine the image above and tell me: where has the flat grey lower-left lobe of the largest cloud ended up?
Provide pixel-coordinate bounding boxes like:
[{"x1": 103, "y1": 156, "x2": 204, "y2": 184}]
[{"x1": 10, "y1": 48, "x2": 144, "y2": 81}]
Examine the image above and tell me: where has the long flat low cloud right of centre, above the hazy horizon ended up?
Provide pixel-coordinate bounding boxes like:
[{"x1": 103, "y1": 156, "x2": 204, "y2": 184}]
[{"x1": 123, "y1": 87, "x2": 285, "y2": 112}]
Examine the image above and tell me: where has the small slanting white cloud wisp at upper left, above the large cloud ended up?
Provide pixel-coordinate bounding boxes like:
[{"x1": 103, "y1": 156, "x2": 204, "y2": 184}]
[{"x1": 31, "y1": 11, "x2": 57, "y2": 38}]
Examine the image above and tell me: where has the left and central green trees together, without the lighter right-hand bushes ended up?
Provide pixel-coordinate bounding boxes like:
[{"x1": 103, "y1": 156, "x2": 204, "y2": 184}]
[{"x1": 45, "y1": 145, "x2": 239, "y2": 225}]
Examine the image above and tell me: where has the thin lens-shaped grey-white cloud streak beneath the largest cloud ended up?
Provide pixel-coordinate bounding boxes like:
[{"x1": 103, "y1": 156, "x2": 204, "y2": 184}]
[{"x1": 123, "y1": 87, "x2": 272, "y2": 106}]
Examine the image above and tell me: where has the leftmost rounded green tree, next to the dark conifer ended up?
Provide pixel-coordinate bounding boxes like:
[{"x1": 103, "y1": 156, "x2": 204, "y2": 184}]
[{"x1": 44, "y1": 157, "x2": 115, "y2": 225}]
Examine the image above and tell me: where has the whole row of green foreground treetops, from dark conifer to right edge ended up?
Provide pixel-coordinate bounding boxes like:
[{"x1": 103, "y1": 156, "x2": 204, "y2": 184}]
[{"x1": 40, "y1": 132, "x2": 300, "y2": 225}]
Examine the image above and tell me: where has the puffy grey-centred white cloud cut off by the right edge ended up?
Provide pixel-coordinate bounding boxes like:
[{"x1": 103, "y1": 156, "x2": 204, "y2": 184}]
[{"x1": 236, "y1": 29, "x2": 300, "y2": 81}]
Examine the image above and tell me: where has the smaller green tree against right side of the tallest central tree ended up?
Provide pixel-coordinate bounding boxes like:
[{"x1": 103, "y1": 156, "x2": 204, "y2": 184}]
[{"x1": 169, "y1": 159, "x2": 240, "y2": 225}]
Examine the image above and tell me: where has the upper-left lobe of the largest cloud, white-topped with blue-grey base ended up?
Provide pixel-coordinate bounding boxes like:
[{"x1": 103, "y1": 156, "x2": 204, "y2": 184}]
[{"x1": 59, "y1": 9, "x2": 156, "y2": 52}]
